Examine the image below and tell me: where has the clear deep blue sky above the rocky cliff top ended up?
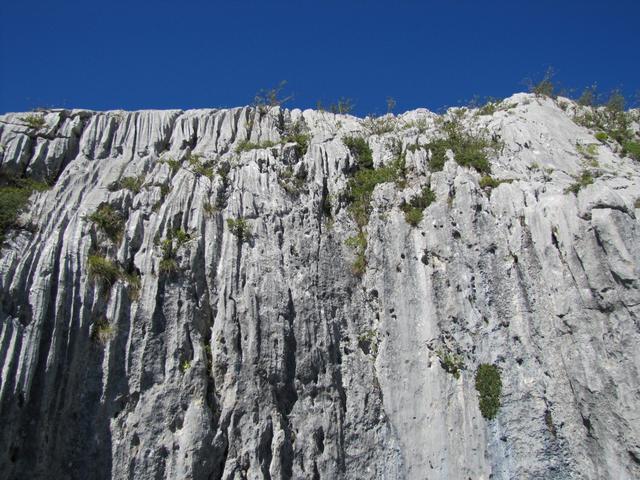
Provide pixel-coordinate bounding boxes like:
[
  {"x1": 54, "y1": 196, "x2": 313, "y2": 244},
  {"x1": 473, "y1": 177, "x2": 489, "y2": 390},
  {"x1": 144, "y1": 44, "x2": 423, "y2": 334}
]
[{"x1": 0, "y1": 0, "x2": 640, "y2": 114}]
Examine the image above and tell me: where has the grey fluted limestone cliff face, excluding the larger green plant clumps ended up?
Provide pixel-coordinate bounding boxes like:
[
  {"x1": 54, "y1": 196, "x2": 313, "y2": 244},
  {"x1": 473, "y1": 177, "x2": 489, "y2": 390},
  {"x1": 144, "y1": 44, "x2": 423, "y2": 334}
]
[{"x1": 0, "y1": 94, "x2": 640, "y2": 480}]
